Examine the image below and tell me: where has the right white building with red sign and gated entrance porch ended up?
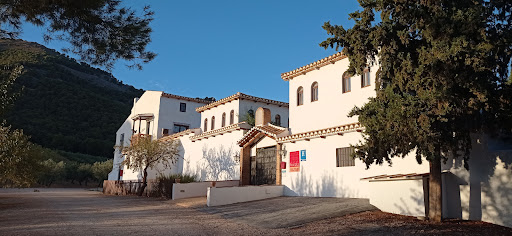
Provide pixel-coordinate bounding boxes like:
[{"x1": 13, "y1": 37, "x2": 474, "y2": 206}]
[{"x1": 238, "y1": 53, "x2": 512, "y2": 226}]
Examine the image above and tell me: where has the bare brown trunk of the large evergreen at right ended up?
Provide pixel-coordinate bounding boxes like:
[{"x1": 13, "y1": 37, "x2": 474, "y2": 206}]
[{"x1": 428, "y1": 157, "x2": 443, "y2": 222}]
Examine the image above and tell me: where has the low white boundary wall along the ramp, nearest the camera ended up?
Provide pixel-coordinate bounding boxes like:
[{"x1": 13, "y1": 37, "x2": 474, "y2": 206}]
[{"x1": 206, "y1": 185, "x2": 284, "y2": 206}]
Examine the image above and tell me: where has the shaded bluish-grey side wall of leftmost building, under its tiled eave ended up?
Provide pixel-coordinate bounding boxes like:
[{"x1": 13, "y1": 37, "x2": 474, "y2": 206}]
[{"x1": 156, "y1": 97, "x2": 206, "y2": 138}]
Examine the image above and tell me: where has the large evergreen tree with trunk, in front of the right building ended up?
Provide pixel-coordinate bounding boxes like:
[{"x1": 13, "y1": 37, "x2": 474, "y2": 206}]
[{"x1": 320, "y1": 0, "x2": 512, "y2": 221}]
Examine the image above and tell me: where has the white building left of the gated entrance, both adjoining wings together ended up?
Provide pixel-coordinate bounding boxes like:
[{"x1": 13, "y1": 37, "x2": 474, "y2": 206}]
[{"x1": 109, "y1": 91, "x2": 288, "y2": 181}]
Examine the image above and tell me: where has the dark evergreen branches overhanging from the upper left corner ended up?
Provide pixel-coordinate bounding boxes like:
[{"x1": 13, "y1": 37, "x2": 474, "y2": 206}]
[{"x1": 0, "y1": 0, "x2": 156, "y2": 69}]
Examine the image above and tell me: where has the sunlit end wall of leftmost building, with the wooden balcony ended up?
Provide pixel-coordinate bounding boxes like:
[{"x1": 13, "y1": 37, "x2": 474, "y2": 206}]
[{"x1": 109, "y1": 91, "x2": 162, "y2": 180}]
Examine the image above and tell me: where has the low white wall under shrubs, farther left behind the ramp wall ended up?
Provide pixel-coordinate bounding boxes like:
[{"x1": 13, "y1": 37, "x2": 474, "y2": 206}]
[{"x1": 172, "y1": 180, "x2": 240, "y2": 200}]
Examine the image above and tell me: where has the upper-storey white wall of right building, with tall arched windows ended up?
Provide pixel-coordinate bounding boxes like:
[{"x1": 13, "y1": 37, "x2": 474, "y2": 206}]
[{"x1": 289, "y1": 59, "x2": 378, "y2": 134}]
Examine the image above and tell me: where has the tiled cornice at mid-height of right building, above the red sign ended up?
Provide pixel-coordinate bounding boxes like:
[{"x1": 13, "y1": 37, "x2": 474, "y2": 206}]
[{"x1": 277, "y1": 122, "x2": 364, "y2": 143}]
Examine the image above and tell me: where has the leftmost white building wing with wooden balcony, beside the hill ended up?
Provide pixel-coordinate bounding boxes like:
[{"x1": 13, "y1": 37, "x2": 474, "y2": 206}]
[{"x1": 108, "y1": 91, "x2": 211, "y2": 180}]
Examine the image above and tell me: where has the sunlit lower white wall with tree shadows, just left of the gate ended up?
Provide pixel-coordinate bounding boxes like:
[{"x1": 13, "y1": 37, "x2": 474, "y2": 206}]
[{"x1": 180, "y1": 130, "x2": 246, "y2": 181}]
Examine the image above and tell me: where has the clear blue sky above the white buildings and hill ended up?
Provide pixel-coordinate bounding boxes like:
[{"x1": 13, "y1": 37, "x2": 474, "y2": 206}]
[{"x1": 21, "y1": 0, "x2": 359, "y2": 102}]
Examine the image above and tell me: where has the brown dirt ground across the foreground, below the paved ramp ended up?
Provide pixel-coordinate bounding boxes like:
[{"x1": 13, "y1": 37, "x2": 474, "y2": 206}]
[{"x1": 0, "y1": 189, "x2": 512, "y2": 236}]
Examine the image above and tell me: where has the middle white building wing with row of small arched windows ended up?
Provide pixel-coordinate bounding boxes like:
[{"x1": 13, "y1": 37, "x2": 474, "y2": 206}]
[{"x1": 161, "y1": 93, "x2": 288, "y2": 181}]
